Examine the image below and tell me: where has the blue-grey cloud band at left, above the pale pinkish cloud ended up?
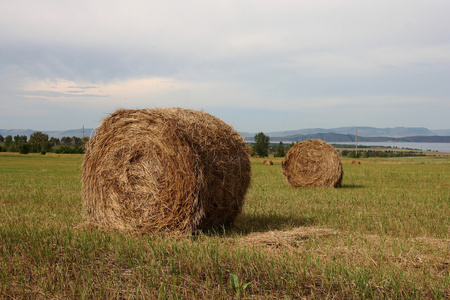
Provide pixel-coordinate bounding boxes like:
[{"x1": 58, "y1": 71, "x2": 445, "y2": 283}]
[{"x1": 0, "y1": 44, "x2": 181, "y2": 83}]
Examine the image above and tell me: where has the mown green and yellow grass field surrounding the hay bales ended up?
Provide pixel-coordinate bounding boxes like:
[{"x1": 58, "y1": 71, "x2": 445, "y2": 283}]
[{"x1": 0, "y1": 153, "x2": 450, "y2": 299}]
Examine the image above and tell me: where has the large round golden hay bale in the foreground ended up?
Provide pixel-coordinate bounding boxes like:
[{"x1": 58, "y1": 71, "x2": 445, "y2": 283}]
[{"x1": 82, "y1": 108, "x2": 250, "y2": 233}]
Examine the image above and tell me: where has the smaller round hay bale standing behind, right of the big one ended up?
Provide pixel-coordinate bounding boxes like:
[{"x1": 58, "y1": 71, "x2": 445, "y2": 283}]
[{"x1": 281, "y1": 140, "x2": 343, "y2": 187}]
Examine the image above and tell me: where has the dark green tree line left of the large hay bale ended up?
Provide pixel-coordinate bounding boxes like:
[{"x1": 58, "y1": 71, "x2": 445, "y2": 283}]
[{"x1": 0, "y1": 131, "x2": 88, "y2": 154}]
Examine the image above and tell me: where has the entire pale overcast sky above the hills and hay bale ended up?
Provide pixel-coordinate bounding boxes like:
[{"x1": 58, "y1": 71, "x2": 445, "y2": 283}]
[{"x1": 0, "y1": 0, "x2": 450, "y2": 132}]
